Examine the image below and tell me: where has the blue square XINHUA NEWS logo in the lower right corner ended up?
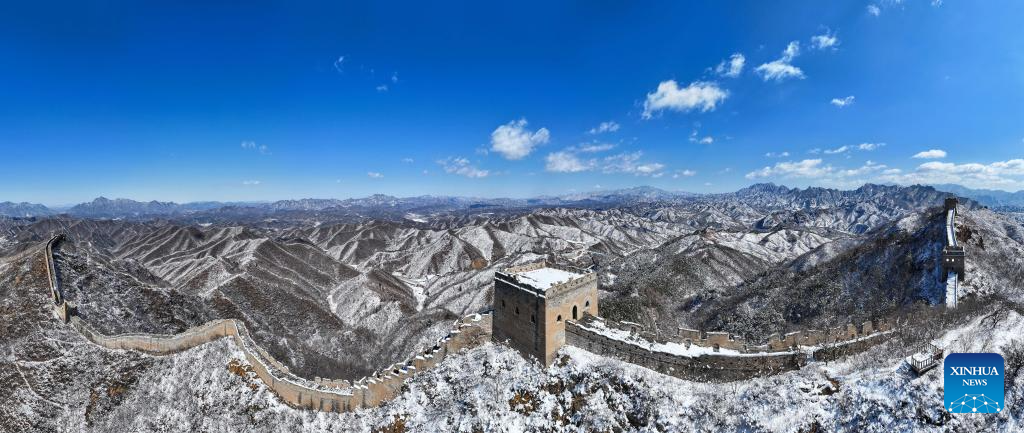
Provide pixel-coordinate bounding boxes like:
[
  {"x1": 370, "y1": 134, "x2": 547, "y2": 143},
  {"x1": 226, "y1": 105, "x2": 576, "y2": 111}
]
[{"x1": 942, "y1": 353, "x2": 1006, "y2": 414}]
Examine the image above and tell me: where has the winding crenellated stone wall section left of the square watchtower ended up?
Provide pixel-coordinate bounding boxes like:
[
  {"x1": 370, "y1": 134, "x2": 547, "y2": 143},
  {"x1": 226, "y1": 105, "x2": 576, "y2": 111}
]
[{"x1": 45, "y1": 234, "x2": 490, "y2": 412}]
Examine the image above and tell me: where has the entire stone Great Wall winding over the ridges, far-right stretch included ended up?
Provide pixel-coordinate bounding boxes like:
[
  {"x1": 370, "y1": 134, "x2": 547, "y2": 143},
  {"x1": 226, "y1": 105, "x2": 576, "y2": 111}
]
[{"x1": 37, "y1": 199, "x2": 964, "y2": 412}]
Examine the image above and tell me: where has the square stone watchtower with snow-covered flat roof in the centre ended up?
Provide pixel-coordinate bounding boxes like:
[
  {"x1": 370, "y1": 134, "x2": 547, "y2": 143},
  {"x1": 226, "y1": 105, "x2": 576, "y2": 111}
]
[{"x1": 493, "y1": 261, "x2": 597, "y2": 365}]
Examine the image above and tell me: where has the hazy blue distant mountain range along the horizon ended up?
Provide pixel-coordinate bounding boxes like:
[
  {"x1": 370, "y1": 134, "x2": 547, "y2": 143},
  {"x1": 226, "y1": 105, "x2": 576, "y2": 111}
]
[{"x1": 0, "y1": 183, "x2": 999, "y2": 220}]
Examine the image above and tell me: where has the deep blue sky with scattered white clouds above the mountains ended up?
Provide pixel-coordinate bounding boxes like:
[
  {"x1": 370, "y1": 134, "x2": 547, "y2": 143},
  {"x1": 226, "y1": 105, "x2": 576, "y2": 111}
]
[{"x1": 0, "y1": 0, "x2": 1024, "y2": 205}]
